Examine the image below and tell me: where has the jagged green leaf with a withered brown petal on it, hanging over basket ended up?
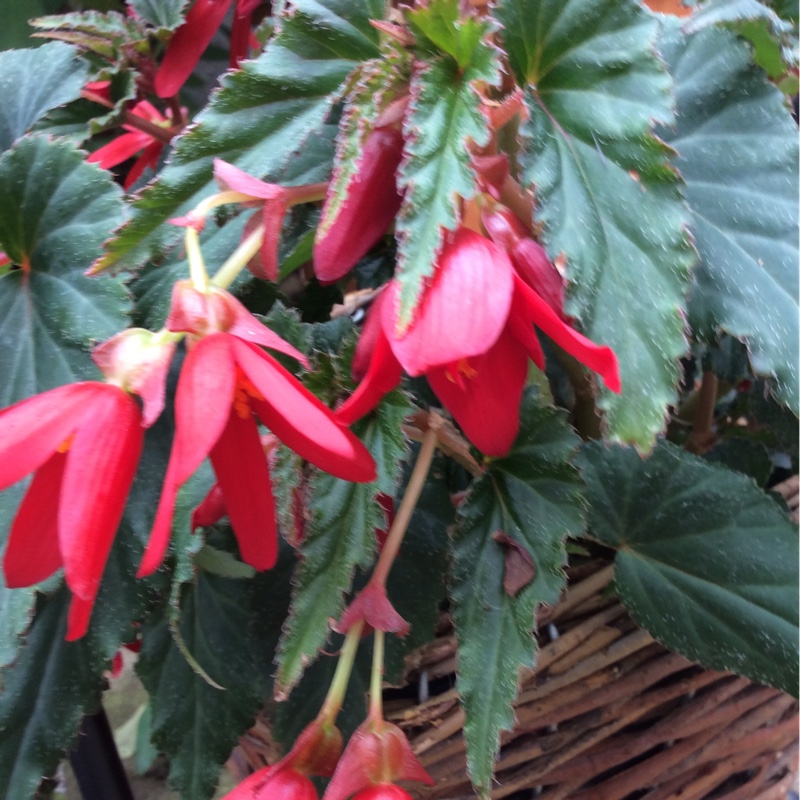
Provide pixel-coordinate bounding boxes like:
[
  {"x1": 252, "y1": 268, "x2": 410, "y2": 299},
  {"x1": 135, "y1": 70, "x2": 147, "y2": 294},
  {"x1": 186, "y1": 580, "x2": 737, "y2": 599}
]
[{"x1": 450, "y1": 390, "x2": 583, "y2": 797}]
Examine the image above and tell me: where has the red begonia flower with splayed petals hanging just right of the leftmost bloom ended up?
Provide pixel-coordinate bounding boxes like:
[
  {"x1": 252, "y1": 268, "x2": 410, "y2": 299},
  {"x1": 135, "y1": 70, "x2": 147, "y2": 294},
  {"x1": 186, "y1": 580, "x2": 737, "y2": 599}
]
[{"x1": 139, "y1": 282, "x2": 375, "y2": 576}]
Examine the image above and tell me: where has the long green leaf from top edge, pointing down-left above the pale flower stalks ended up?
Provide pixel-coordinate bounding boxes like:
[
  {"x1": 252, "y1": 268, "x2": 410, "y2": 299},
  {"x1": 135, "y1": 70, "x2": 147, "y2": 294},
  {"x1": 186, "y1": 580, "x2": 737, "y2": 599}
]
[{"x1": 98, "y1": 0, "x2": 383, "y2": 268}]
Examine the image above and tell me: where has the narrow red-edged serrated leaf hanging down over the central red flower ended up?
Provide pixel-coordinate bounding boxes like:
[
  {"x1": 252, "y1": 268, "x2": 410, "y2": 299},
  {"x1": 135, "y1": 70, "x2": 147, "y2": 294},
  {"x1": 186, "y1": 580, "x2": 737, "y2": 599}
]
[{"x1": 396, "y1": 27, "x2": 501, "y2": 328}]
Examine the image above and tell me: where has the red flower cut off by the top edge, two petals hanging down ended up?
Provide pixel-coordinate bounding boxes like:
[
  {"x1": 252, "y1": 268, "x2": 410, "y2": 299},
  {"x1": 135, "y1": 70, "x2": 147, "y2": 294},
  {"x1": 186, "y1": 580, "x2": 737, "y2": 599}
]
[{"x1": 155, "y1": 0, "x2": 261, "y2": 97}]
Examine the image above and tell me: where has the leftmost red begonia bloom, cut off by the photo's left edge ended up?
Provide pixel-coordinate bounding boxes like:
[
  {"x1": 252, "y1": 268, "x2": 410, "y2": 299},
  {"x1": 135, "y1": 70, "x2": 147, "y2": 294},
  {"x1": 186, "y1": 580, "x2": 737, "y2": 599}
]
[{"x1": 0, "y1": 381, "x2": 143, "y2": 641}]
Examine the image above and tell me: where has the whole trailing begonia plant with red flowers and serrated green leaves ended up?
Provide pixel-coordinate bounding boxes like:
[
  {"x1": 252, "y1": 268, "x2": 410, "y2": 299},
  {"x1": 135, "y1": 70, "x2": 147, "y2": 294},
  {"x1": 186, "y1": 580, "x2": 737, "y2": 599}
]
[{"x1": 0, "y1": 0, "x2": 800, "y2": 800}]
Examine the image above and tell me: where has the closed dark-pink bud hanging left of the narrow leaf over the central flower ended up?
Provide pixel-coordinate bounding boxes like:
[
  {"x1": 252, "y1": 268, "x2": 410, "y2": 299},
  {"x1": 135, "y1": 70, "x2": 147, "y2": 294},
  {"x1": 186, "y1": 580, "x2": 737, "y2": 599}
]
[{"x1": 314, "y1": 128, "x2": 403, "y2": 283}]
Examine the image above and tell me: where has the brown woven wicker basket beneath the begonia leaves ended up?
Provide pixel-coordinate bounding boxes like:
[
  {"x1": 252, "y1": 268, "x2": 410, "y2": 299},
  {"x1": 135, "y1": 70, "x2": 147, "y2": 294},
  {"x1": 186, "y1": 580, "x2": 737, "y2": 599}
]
[{"x1": 231, "y1": 564, "x2": 798, "y2": 800}]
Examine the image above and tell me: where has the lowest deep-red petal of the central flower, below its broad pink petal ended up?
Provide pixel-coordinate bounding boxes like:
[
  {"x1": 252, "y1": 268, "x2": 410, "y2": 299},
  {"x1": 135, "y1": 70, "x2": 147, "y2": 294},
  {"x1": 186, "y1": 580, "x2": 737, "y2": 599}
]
[{"x1": 426, "y1": 329, "x2": 528, "y2": 456}]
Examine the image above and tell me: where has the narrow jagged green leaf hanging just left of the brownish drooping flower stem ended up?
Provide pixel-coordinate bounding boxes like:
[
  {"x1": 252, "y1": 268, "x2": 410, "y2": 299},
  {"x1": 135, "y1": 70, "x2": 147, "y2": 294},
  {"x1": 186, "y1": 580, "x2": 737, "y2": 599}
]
[{"x1": 277, "y1": 392, "x2": 410, "y2": 694}]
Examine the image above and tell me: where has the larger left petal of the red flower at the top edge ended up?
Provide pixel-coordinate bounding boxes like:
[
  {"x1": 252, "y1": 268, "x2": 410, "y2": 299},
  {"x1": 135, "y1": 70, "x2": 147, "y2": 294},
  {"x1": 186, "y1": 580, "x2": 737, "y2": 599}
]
[{"x1": 155, "y1": 0, "x2": 231, "y2": 97}]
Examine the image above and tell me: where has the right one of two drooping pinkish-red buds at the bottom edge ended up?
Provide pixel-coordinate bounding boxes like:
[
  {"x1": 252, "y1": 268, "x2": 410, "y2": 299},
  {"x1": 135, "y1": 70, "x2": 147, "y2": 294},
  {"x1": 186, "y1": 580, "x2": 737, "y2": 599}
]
[{"x1": 324, "y1": 718, "x2": 434, "y2": 800}]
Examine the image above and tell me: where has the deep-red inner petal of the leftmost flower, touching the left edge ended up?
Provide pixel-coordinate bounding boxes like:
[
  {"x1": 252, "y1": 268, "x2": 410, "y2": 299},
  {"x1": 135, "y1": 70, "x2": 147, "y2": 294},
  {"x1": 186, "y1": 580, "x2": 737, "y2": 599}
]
[{"x1": 3, "y1": 452, "x2": 67, "y2": 589}]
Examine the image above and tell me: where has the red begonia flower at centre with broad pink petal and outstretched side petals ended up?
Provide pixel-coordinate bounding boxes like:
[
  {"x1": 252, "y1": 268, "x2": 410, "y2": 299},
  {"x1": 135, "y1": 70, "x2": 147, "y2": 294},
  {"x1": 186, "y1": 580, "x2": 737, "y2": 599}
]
[{"x1": 337, "y1": 228, "x2": 621, "y2": 456}]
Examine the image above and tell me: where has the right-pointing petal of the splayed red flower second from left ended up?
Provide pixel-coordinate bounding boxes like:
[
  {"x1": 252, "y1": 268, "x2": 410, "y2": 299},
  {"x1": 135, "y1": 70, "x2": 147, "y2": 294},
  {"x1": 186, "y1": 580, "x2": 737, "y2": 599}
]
[{"x1": 233, "y1": 340, "x2": 376, "y2": 482}]
